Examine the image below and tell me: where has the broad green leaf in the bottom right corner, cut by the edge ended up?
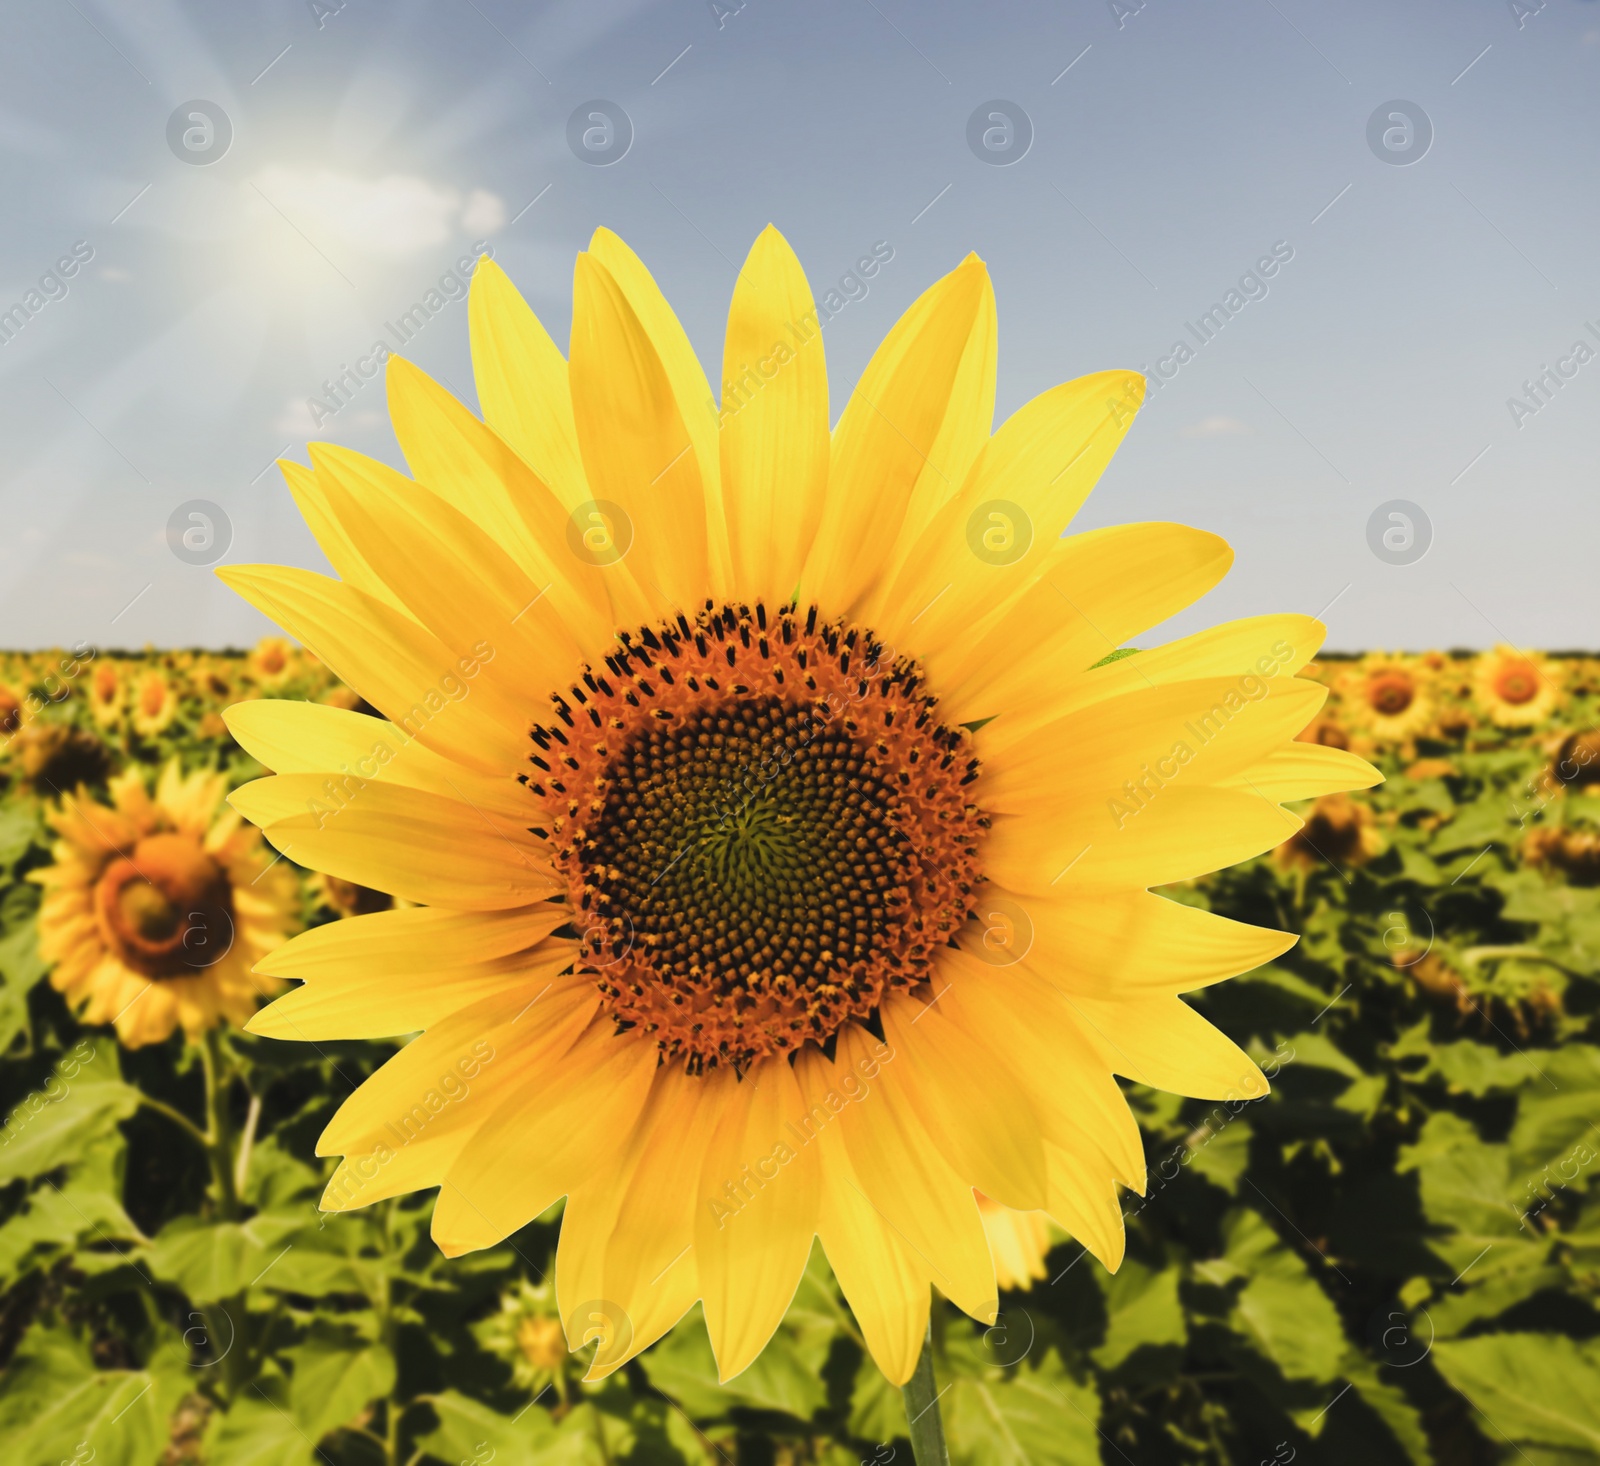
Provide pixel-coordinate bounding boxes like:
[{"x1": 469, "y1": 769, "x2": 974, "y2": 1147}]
[{"x1": 1434, "y1": 1333, "x2": 1600, "y2": 1456}]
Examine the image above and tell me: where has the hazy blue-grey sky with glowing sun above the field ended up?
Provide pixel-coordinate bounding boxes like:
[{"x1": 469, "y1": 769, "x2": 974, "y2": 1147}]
[{"x1": 0, "y1": 0, "x2": 1600, "y2": 650}]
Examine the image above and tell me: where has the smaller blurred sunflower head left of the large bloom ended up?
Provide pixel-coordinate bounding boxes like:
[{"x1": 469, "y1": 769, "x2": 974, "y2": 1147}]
[{"x1": 29, "y1": 759, "x2": 298, "y2": 1048}]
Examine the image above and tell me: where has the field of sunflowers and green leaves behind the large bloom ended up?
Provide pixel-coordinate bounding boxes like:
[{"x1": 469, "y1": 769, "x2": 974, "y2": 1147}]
[{"x1": 0, "y1": 639, "x2": 1600, "y2": 1466}]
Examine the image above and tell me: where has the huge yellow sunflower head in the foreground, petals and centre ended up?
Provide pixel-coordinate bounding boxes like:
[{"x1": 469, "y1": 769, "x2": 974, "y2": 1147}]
[{"x1": 218, "y1": 229, "x2": 1378, "y2": 1383}]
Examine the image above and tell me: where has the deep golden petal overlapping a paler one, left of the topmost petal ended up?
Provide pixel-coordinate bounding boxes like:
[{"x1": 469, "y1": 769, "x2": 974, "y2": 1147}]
[{"x1": 571, "y1": 254, "x2": 710, "y2": 621}]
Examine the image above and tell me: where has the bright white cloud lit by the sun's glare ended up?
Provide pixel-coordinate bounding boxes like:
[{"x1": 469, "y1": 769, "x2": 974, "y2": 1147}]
[{"x1": 254, "y1": 163, "x2": 506, "y2": 256}]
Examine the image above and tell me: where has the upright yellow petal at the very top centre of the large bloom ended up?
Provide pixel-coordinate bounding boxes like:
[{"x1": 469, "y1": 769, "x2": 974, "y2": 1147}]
[{"x1": 720, "y1": 224, "x2": 829, "y2": 605}]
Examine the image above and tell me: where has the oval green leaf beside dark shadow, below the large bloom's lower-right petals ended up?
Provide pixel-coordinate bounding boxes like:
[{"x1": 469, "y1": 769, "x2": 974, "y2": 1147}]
[{"x1": 1222, "y1": 1212, "x2": 1346, "y2": 1383}]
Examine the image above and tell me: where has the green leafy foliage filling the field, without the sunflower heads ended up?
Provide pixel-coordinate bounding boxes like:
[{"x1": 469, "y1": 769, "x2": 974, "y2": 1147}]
[{"x1": 0, "y1": 653, "x2": 1600, "y2": 1466}]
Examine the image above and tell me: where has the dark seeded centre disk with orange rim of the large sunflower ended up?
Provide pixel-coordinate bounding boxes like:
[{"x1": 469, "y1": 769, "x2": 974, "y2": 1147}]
[{"x1": 528, "y1": 602, "x2": 987, "y2": 1069}]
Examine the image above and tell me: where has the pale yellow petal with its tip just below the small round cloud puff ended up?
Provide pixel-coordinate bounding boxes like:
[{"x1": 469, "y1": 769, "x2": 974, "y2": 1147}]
[{"x1": 467, "y1": 259, "x2": 590, "y2": 511}]
